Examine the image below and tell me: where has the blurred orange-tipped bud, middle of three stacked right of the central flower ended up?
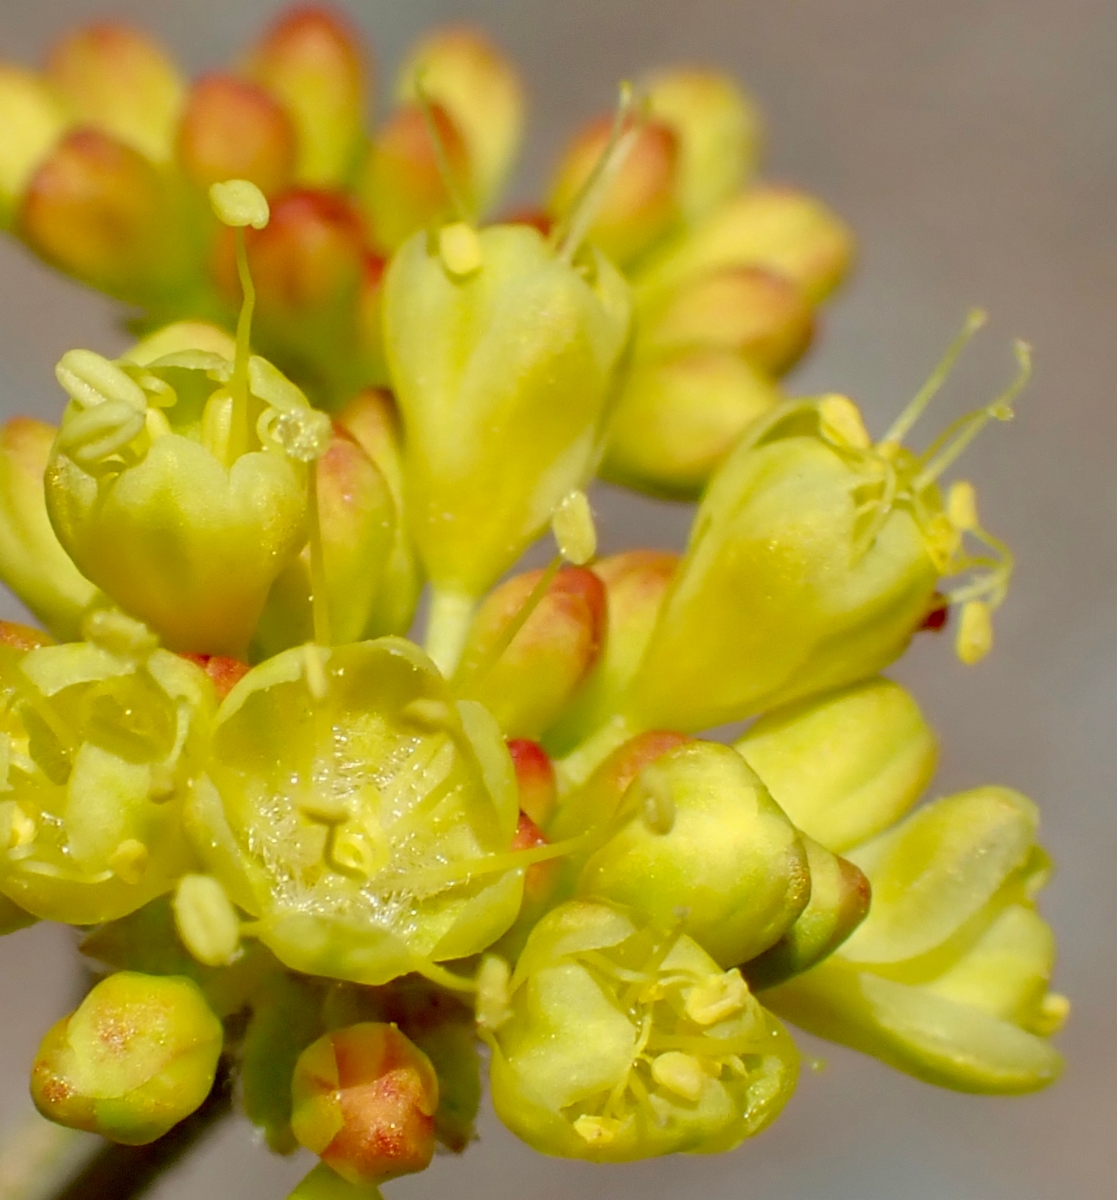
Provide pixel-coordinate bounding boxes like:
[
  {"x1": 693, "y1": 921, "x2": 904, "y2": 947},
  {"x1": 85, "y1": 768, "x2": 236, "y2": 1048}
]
[{"x1": 637, "y1": 266, "x2": 812, "y2": 373}]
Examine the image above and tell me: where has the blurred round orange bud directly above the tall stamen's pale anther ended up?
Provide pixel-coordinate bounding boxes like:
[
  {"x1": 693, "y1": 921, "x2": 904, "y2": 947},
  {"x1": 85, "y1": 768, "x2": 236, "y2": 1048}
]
[{"x1": 178, "y1": 74, "x2": 296, "y2": 196}]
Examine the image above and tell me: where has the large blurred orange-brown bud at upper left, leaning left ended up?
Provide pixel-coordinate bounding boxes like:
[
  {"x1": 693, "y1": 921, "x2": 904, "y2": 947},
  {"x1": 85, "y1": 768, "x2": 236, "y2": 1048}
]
[{"x1": 17, "y1": 128, "x2": 190, "y2": 306}]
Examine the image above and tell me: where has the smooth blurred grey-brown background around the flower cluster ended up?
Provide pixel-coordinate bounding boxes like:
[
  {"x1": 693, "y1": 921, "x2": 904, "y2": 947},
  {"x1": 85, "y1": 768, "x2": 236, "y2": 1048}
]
[{"x1": 0, "y1": 0, "x2": 1117, "y2": 1200}]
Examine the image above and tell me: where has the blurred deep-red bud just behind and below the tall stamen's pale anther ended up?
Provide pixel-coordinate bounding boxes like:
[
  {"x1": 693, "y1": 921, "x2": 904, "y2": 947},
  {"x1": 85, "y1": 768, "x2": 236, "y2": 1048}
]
[{"x1": 215, "y1": 190, "x2": 373, "y2": 403}]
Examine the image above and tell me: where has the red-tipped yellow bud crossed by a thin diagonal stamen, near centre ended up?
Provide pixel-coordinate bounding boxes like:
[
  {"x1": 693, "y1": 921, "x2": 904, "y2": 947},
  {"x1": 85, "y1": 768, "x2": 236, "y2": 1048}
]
[{"x1": 458, "y1": 566, "x2": 605, "y2": 738}]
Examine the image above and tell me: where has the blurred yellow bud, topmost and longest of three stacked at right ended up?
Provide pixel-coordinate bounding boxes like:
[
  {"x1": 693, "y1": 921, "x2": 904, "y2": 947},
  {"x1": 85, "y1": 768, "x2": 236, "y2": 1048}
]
[{"x1": 636, "y1": 186, "x2": 853, "y2": 304}]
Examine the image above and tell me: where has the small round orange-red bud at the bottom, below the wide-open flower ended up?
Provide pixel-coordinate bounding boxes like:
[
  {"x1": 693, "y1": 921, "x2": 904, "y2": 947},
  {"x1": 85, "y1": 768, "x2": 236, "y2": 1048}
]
[{"x1": 292, "y1": 1021, "x2": 438, "y2": 1183}]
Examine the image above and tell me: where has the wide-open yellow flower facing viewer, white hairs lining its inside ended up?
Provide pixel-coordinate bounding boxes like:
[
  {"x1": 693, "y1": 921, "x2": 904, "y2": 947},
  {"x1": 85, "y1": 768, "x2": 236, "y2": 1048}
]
[{"x1": 188, "y1": 638, "x2": 522, "y2": 984}]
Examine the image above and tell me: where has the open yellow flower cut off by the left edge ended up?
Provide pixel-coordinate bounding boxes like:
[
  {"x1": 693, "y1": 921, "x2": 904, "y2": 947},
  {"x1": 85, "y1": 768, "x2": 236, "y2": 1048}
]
[{"x1": 0, "y1": 633, "x2": 215, "y2": 925}]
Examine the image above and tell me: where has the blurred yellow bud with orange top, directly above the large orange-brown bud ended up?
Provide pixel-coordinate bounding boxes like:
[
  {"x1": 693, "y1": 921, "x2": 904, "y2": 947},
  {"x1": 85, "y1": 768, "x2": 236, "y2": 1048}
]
[{"x1": 47, "y1": 24, "x2": 186, "y2": 162}]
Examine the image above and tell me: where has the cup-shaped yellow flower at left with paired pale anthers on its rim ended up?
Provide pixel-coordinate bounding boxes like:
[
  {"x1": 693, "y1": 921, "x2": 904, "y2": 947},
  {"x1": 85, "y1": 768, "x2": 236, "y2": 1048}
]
[{"x1": 46, "y1": 338, "x2": 319, "y2": 658}]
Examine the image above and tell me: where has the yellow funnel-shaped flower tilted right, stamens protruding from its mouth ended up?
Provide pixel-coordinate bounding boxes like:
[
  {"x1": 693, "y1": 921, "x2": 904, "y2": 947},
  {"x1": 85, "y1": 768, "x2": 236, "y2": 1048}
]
[{"x1": 623, "y1": 379, "x2": 1027, "y2": 730}]
